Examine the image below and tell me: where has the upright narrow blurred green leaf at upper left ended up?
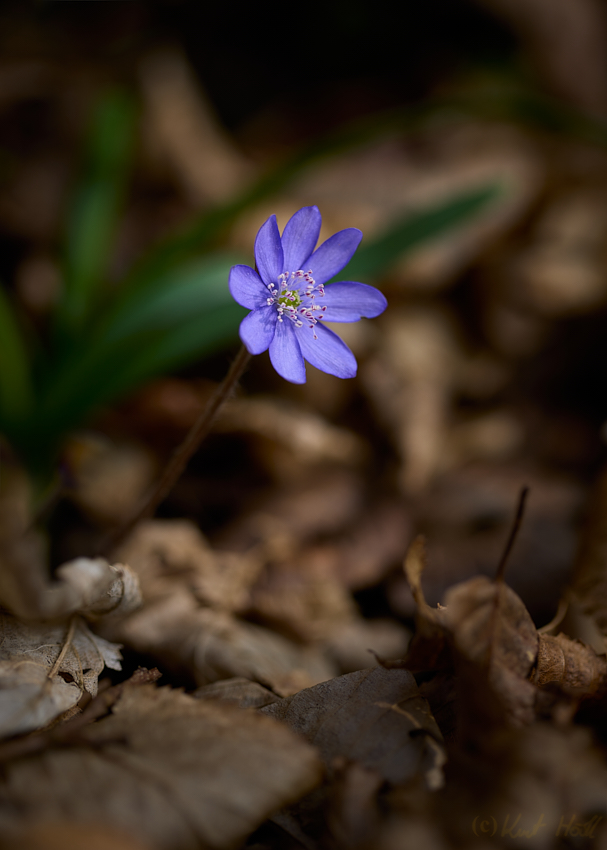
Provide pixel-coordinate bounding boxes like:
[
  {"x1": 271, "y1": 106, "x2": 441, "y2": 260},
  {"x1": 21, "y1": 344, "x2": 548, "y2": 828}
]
[{"x1": 56, "y1": 91, "x2": 136, "y2": 335}]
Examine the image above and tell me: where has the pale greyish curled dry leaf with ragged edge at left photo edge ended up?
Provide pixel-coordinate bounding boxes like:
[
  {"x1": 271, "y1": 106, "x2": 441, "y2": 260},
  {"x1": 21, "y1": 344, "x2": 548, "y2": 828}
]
[{"x1": 0, "y1": 471, "x2": 141, "y2": 735}]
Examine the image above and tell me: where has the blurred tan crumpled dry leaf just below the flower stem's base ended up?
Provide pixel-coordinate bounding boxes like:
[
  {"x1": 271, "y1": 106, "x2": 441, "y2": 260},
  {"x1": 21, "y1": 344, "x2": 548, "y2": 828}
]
[{"x1": 109, "y1": 520, "x2": 335, "y2": 696}]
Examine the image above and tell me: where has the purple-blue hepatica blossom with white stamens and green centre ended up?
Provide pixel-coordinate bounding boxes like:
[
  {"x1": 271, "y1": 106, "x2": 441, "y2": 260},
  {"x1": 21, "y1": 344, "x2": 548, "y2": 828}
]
[{"x1": 230, "y1": 207, "x2": 387, "y2": 384}]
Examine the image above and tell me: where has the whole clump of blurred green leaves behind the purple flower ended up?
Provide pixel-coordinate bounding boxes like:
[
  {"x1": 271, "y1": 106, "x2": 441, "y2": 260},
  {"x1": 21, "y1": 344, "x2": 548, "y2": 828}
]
[{"x1": 0, "y1": 92, "x2": 504, "y2": 475}]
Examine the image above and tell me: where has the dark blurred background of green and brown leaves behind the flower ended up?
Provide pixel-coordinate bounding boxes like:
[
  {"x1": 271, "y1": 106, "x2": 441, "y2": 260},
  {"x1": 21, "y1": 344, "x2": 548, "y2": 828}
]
[{"x1": 0, "y1": 0, "x2": 607, "y2": 636}]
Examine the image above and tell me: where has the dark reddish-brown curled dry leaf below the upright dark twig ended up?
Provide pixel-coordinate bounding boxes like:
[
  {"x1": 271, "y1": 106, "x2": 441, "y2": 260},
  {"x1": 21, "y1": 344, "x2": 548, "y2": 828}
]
[{"x1": 402, "y1": 538, "x2": 607, "y2": 737}]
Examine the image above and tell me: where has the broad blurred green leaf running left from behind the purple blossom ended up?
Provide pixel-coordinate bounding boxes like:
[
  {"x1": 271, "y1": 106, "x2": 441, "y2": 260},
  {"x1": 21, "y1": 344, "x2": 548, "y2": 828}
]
[{"x1": 34, "y1": 252, "x2": 246, "y2": 450}]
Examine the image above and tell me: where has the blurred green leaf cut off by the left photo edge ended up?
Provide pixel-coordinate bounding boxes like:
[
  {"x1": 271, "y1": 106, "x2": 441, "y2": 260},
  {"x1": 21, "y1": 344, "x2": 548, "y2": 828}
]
[{"x1": 0, "y1": 287, "x2": 33, "y2": 424}]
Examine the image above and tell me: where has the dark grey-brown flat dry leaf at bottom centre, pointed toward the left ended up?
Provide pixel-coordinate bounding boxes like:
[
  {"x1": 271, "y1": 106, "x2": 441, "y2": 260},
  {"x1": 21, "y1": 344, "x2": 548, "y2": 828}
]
[{"x1": 261, "y1": 667, "x2": 445, "y2": 788}]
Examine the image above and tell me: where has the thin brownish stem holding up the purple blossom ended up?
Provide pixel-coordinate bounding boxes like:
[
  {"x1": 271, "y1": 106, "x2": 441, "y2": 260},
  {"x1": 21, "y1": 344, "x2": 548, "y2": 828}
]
[{"x1": 99, "y1": 345, "x2": 251, "y2": 554}]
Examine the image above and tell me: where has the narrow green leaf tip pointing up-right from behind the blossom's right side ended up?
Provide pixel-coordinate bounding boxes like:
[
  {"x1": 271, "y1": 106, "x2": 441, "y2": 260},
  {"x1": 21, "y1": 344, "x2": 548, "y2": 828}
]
[{"x1": 339, "y1": 185, "x2": 503, "y2": 281}]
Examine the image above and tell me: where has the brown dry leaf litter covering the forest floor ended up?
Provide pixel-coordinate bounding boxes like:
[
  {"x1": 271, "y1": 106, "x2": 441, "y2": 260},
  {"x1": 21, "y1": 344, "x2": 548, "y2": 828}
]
[{"x1": 0, "y1": 33, "x2": 607, "y2": 850}]
